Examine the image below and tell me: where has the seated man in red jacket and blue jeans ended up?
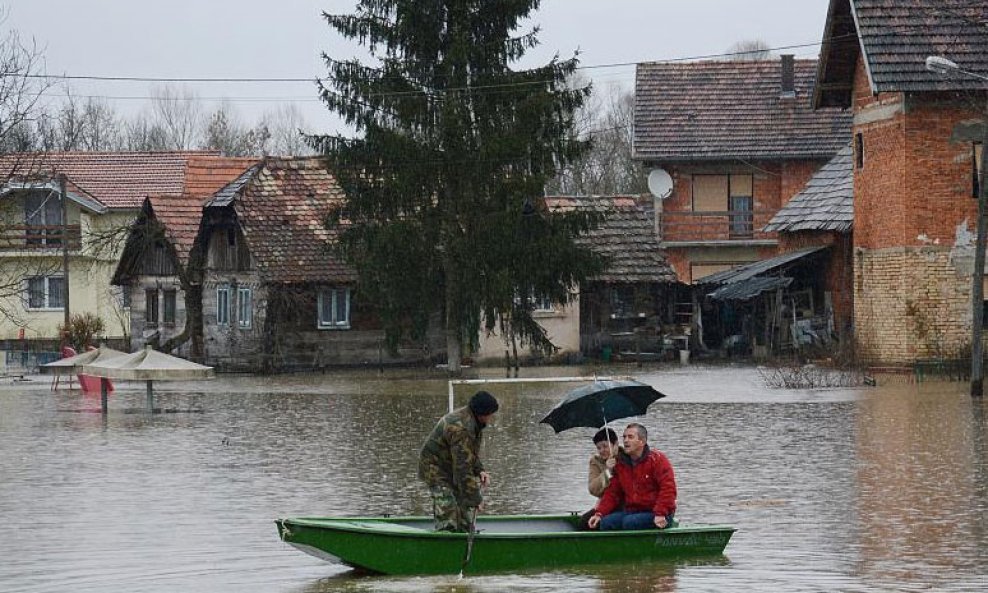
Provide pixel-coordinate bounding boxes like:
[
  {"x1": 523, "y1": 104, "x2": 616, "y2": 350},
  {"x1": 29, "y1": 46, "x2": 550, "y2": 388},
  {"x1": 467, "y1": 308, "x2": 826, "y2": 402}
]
[{"x1": 589, "y1": 423, "x2": 676, "y2": 530}]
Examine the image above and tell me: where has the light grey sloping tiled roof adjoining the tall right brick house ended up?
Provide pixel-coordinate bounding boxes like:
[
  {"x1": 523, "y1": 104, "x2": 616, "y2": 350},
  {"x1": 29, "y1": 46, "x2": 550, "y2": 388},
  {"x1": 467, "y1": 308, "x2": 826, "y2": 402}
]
[{"x1": 764, "y1": 145, "x2": 854, "y2": 233}]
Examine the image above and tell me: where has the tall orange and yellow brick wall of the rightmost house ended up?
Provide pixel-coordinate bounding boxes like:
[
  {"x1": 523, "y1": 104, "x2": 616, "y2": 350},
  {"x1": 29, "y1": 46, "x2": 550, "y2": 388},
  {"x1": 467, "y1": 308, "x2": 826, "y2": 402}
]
[{"x1": 853, "y1": 53, "x2": 977, "y2": 363}]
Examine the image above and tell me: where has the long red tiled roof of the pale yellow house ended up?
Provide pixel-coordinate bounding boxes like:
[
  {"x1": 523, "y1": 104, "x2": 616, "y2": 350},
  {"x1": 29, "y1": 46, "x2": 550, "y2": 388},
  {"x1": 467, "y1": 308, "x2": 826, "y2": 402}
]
[{"x1": 0, "y1": 150, "x2": 224, "y2": 208}]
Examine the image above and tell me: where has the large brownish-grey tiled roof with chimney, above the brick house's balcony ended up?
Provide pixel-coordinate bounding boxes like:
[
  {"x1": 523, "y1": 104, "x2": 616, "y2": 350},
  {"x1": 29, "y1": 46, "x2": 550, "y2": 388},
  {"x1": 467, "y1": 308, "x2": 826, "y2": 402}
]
[{"x1": 634, "y1": 60, "x2": 851, "y2": 162}]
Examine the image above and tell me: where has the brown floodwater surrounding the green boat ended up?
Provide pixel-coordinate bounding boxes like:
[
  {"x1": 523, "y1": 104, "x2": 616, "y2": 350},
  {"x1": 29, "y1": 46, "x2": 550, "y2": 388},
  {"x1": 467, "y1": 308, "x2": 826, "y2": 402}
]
[{"x1": 0, "y1": 366, "x2": 988, "y2": 593}]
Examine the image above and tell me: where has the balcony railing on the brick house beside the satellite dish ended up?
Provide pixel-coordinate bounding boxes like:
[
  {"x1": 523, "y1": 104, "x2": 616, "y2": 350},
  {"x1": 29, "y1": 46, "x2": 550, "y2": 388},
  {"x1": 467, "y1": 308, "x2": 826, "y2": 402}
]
[{"x1": 660, "y1": 210, "x2": 778, "y2": 243}]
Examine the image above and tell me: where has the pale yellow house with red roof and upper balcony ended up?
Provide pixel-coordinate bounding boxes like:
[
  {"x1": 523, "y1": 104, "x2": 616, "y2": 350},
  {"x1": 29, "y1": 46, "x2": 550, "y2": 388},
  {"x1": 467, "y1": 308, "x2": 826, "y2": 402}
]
[{"x1": 0, "y1": 151, "x2": 246, "y2": 371}]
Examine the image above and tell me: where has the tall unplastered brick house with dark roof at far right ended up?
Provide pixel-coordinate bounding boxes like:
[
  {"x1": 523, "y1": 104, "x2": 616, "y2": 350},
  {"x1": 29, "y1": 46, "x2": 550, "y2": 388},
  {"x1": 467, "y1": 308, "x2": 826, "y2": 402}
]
[{"x1": 813, "y1": 0, "x2": 988, "y2": 363}]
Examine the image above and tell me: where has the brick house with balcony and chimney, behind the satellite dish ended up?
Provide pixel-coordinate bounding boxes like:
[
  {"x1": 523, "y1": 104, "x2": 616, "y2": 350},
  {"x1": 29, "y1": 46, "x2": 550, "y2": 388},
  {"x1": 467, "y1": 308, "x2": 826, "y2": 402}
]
[{"x1": 633, "y1": 56, "x2": 850, "y2": 283}]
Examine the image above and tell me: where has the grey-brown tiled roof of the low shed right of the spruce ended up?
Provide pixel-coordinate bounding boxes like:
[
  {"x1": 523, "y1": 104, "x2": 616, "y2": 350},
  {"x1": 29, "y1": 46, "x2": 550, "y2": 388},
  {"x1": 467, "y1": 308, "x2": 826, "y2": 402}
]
[{"x1": 545, "y1": 196, "x2": 677, "y2": 284}]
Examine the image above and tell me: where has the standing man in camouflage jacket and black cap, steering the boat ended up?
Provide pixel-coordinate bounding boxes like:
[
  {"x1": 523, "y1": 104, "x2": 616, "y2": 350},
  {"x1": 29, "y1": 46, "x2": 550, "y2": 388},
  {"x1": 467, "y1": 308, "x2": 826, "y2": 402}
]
[{"x1": 419, "y1": 391, "x2": 498, "y2": 531}]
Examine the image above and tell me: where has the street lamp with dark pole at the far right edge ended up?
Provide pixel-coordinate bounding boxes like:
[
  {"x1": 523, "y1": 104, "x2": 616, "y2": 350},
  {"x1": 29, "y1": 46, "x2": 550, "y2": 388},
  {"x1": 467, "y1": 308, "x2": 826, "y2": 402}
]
[{"x1": 926, "y1": 56, "x2": 988, "y2": 397}]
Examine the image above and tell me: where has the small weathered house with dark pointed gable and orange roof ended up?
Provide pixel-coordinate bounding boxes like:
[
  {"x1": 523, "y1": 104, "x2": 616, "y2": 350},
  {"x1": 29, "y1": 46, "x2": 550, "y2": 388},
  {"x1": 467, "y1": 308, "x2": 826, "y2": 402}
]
[{"x1": 112, "y1": 156, "x2": 257, "y2": 359}]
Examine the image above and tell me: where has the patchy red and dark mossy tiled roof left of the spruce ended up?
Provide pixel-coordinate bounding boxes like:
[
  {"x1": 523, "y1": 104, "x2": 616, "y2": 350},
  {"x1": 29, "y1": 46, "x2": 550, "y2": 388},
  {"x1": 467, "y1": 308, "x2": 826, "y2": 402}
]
[{"x1": 233, "y1": 158, "x2": 356, "y2": 283}]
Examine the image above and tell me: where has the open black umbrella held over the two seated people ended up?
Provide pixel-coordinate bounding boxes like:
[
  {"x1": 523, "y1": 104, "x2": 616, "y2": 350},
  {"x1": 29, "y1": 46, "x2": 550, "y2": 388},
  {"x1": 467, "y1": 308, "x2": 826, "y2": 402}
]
[{"x1": 539, "y1": 381, "x2": 665, "y2": 432}]
